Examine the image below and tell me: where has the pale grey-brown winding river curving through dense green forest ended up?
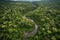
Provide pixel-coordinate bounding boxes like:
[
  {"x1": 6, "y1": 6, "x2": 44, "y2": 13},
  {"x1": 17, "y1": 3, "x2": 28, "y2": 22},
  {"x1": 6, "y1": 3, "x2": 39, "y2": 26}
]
[{"x1": 23, "y1": 19, "x2": 38, "y2": 40}]
